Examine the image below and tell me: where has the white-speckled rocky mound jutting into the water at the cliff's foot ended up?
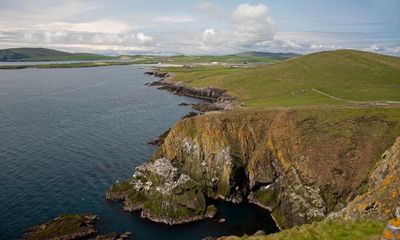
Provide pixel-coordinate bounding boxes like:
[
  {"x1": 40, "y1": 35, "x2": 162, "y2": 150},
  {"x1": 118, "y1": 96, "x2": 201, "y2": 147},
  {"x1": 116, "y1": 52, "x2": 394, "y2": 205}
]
[{"x1": 106, "y1": 158, "x2": 216, "y2": 225}]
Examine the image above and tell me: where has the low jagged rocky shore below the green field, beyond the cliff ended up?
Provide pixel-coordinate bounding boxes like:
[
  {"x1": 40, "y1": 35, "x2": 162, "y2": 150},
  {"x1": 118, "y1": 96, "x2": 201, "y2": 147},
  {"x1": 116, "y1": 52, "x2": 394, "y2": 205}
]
[{"x1": 145, "y1": 71, "x2": 238, "y2": 112}]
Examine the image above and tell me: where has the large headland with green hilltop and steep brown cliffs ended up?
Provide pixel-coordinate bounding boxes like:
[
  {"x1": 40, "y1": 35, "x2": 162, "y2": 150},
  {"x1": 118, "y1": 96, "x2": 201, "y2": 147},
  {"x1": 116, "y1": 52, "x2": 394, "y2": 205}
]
[{"x1": 107, "y1": 50, "x2": 400, "y2": 239}]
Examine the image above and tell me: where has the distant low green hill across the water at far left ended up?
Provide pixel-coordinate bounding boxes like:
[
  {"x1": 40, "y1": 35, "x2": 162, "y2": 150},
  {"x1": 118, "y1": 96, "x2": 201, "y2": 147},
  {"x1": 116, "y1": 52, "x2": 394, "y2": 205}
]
[{"x1": 0, "y1": 48, "x2": 113, "y2": 62}]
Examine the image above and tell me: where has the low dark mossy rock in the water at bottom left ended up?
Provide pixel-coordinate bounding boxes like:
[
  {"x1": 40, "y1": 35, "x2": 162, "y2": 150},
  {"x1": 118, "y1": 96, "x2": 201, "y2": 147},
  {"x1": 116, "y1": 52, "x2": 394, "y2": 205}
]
[{"x1": 23, "y1": 214, "x2": 97, "y2": 240}]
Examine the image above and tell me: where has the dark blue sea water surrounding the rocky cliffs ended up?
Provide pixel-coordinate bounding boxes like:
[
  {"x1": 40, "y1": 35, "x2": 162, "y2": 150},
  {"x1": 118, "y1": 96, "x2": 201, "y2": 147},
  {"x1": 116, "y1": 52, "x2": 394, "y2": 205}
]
[{"x1": 0, "y1": 66, "x2": 276, "y2": 239}]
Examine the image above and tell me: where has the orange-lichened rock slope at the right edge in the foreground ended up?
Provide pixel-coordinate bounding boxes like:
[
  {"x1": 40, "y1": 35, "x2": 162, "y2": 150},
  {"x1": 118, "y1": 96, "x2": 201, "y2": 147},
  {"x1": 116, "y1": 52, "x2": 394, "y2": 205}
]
[{"x1": 330, "y1": 137, "x2": 400, "y2": 222}]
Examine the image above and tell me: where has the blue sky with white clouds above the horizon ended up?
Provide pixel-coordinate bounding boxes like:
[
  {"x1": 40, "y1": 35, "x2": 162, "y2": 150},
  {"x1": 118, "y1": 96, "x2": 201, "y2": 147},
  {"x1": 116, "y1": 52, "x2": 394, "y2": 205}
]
[{"x1": 0, "y1": 0, "x2": 400, "y2": 56}]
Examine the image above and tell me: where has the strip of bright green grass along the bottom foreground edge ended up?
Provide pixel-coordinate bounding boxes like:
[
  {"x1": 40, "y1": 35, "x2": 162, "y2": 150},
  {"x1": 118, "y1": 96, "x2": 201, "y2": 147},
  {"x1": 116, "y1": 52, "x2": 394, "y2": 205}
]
[{"x1": 223, "y1": 220, "x2": 385, "y2": 240}]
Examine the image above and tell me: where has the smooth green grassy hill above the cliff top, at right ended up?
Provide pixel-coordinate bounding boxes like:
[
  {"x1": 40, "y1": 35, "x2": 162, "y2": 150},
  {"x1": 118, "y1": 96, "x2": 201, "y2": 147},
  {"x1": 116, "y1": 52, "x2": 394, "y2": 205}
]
[{"x1": 163, "y1": 50, "x2": 400, "y2": 107}]
